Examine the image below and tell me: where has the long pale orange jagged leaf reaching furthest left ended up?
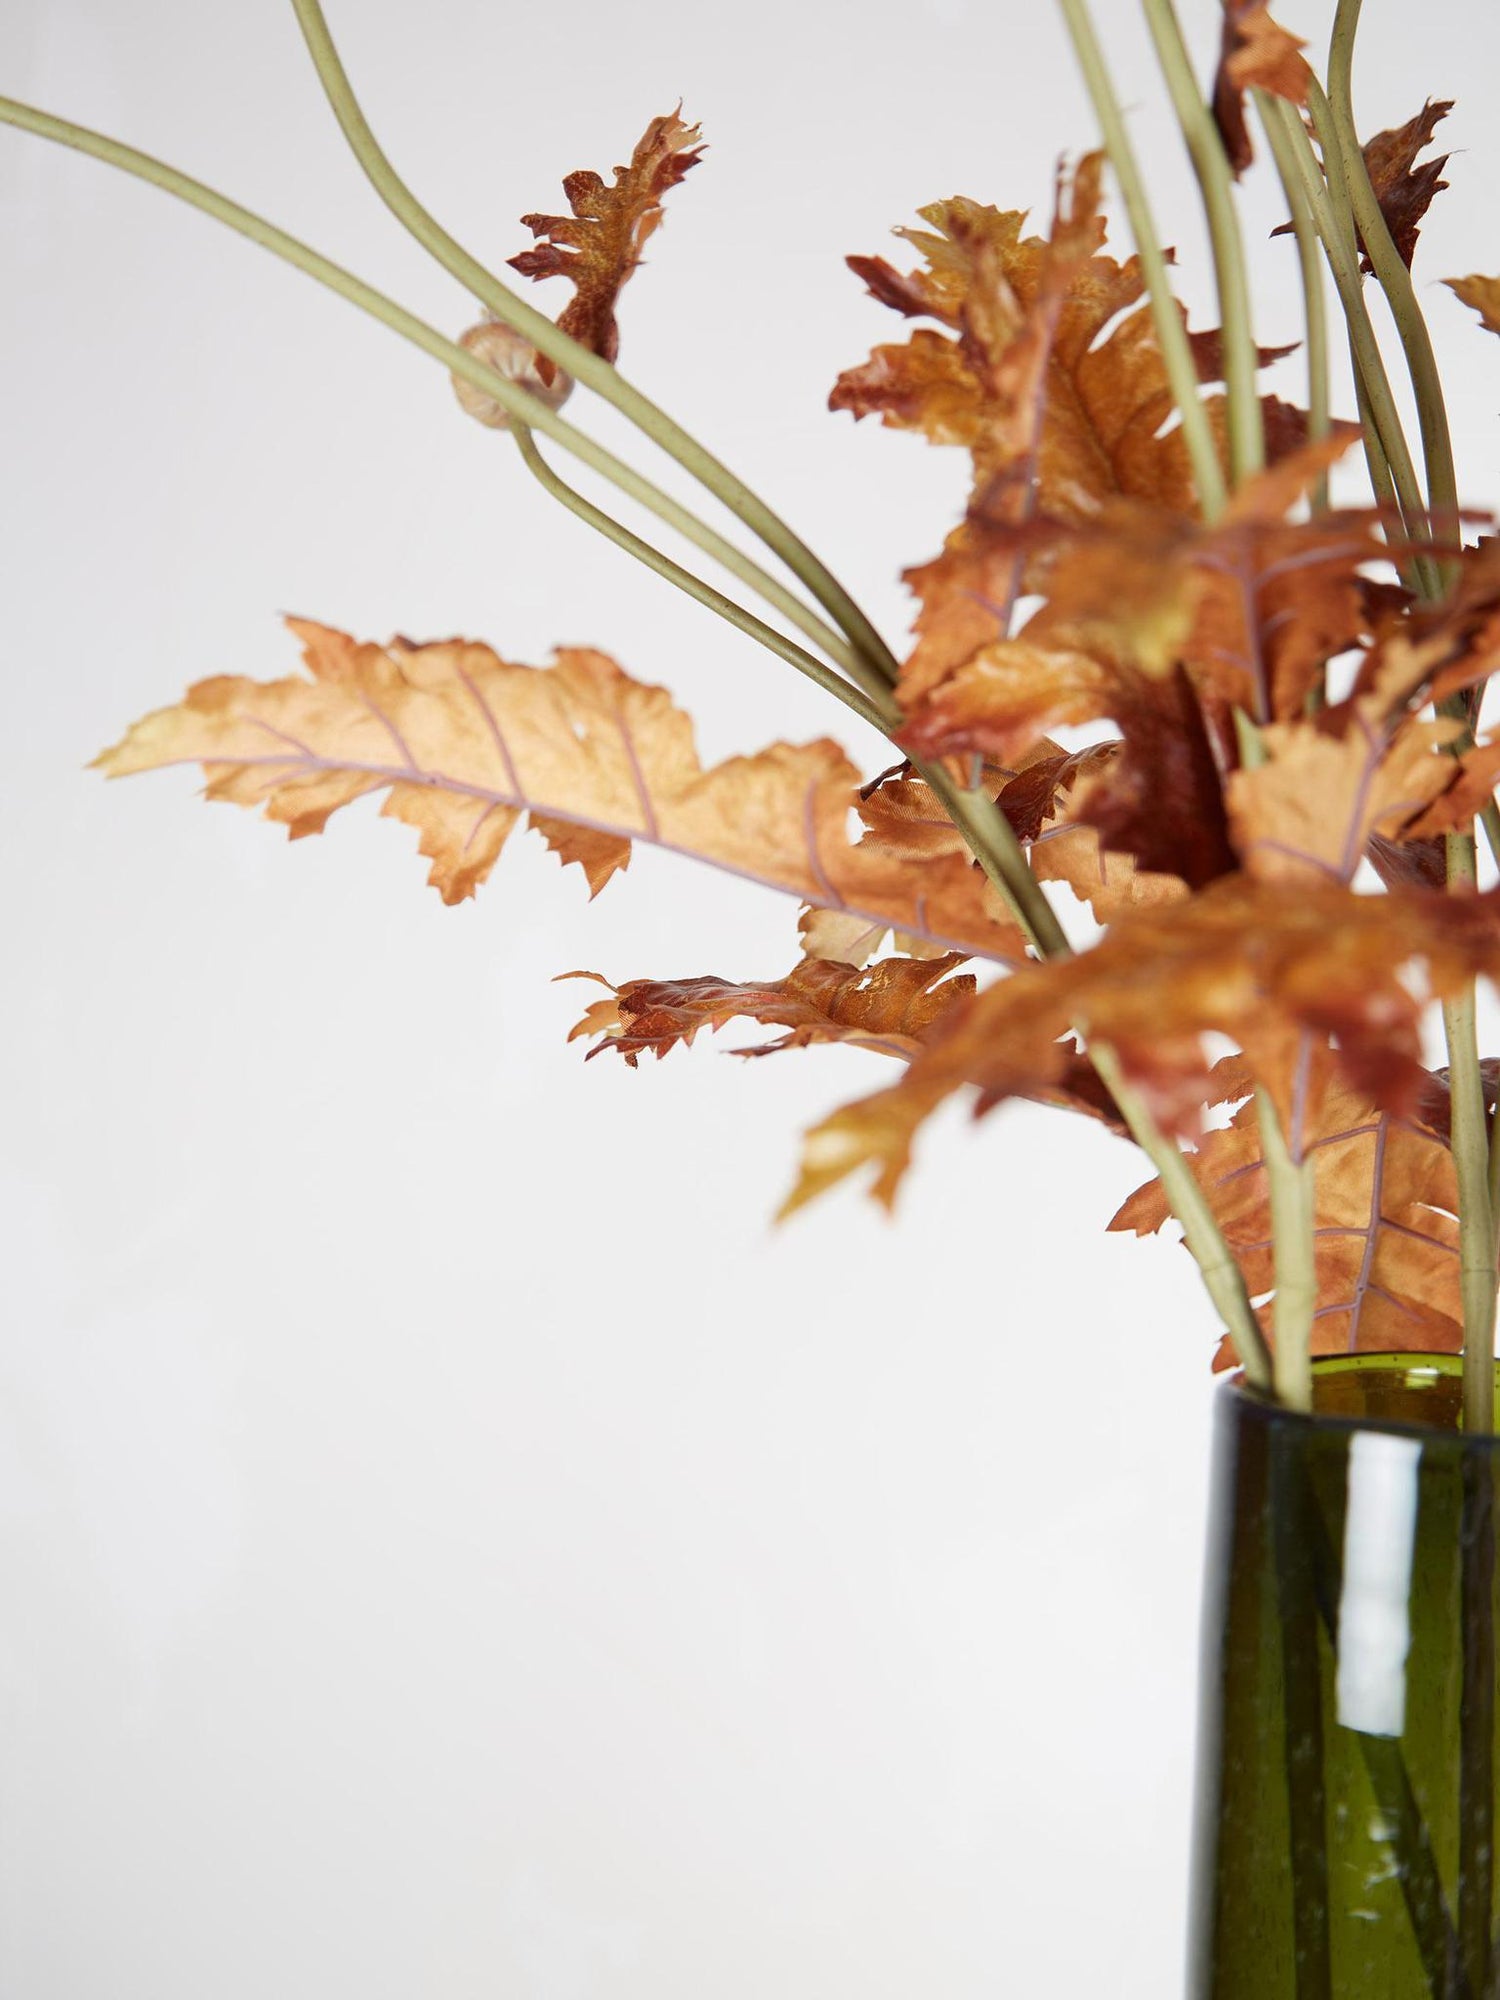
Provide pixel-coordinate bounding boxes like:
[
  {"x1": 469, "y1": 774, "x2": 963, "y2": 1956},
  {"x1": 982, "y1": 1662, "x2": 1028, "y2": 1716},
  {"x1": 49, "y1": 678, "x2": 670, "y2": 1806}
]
[{"x1": 98, "y1": 620, "x2": 1024, "y2": 962}]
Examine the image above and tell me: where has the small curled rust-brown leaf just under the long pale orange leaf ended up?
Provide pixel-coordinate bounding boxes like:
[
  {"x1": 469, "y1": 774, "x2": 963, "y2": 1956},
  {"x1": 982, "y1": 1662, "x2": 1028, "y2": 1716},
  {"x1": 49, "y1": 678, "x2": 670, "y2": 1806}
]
[{"x1": 570, "y1": 952, "x2": 976, "y2": 1068}]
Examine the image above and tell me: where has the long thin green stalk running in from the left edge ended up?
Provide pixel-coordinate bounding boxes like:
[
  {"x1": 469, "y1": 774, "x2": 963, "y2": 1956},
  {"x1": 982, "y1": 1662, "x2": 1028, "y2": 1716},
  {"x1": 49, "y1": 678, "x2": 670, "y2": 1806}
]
[{"x1": 0, "y1": 98, "x2": 886, "y2": 694}]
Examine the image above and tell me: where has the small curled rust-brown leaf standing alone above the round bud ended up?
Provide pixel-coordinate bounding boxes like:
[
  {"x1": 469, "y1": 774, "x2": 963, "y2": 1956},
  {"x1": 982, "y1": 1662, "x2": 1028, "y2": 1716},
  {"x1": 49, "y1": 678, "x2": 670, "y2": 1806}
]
[{"x1": 510, "y1": 106, "x2": 704, "y2": 366}]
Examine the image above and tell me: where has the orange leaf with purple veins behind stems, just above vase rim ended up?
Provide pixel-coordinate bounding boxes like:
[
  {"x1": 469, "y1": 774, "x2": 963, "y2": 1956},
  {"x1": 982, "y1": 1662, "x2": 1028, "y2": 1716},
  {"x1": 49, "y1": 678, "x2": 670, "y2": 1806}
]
[{"x1": 1110, "y1": 1050, "x2": 1462, "y2": 1366}]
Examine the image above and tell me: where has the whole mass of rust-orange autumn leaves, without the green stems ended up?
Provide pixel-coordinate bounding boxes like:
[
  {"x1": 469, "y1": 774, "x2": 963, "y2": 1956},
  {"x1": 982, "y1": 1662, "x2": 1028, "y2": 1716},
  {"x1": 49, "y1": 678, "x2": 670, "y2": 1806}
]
[{"x1": 100, "y1": 70, "x2": 1500, "y2": 1350}]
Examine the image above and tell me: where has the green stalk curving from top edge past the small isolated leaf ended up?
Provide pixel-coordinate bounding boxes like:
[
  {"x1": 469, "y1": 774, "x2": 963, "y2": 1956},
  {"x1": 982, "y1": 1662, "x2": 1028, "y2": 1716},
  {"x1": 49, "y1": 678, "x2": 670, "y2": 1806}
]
[{"x1": 292, "y1": 0, "x2": 896, "y2": 682}]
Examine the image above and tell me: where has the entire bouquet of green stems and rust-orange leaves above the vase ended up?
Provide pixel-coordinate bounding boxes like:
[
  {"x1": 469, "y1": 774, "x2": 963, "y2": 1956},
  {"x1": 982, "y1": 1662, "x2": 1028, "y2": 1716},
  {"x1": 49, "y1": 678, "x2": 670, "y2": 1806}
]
[{"x1": 0, "y1": 0, "x2": 1500, "y2": 1430}]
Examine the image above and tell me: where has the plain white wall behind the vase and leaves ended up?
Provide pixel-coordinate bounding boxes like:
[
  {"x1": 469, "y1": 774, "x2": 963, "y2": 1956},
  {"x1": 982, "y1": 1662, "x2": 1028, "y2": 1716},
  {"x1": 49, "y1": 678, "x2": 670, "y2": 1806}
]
[{"x1": 0, "y1": 0, "x2": 1500, "y2": 2000}]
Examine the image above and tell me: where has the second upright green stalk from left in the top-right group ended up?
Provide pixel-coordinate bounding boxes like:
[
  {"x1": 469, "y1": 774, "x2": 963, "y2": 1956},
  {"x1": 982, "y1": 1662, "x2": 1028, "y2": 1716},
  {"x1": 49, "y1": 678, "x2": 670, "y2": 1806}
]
[{"x1": 1142, "y1": 0, "x2": 1266, "y2": 486}]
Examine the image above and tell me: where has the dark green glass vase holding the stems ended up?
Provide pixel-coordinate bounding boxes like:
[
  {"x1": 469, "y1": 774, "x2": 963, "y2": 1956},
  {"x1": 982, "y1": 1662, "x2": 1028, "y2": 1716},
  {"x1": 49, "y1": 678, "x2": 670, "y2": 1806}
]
[{"x1": 1188, "y1": 1354, "x2": 1500, "y2": 2000}]
